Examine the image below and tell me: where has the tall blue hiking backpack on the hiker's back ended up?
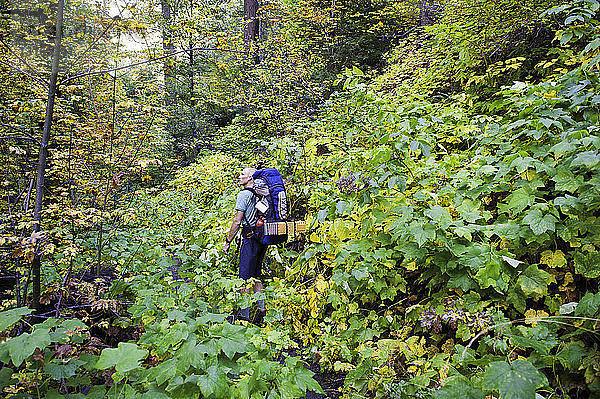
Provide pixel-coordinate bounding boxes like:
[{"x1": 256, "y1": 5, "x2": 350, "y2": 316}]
[{"x1": 249, "y1": 168, "x2": 288, "y2": 245}]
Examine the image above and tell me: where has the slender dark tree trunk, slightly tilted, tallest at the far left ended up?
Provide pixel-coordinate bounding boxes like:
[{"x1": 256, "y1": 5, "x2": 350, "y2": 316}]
[{"x1": 31, "y1": 0, "x2": 65, "y2": 309}]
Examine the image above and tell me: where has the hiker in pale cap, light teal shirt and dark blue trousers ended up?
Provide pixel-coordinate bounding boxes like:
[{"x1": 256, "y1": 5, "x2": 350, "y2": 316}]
[{"x1": 223, "y1": 168, "x2": 267, "y2": 320}]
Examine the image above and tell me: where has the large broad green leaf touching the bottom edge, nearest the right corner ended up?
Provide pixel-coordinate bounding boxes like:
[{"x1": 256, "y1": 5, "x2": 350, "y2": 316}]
[{"x1": 483, "y1": 360, "x2": 546, "y2": 399}]
